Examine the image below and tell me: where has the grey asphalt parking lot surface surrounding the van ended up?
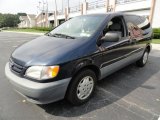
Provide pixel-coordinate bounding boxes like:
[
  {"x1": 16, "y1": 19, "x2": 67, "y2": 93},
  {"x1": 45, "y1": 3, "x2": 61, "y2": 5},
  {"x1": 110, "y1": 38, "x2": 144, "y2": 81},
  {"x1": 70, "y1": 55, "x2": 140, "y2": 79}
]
[{"x1": 0, "y1": 32, "x2": 160, "y2": 120}]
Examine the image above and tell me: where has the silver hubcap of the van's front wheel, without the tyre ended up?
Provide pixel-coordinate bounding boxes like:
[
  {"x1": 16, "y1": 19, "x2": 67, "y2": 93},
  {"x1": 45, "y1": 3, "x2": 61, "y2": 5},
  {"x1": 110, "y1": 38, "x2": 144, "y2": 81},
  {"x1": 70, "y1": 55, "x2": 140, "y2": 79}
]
[{"x1": 77, "y1": 76, "x2": 94, "y2": 100}]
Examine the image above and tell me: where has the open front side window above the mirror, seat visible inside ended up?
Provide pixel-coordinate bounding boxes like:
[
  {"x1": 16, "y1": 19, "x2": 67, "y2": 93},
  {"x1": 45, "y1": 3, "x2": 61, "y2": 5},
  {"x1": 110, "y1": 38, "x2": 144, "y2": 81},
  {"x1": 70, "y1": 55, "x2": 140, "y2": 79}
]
[{"x1": 103, "y1": 17, "x2": 126, "y2": 38}]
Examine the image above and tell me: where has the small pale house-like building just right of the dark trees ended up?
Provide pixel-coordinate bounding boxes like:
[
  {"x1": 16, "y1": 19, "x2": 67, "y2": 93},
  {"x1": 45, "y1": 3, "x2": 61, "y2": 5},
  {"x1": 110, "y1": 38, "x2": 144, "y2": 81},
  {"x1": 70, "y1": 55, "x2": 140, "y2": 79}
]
[{"x1": 18, "y1": 14, "x2": 36, "y2": 28}]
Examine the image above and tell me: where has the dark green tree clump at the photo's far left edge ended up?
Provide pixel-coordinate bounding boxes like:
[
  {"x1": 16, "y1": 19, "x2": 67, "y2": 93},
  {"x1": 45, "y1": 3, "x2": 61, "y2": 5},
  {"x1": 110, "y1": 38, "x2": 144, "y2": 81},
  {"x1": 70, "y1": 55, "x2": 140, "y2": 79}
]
[{"x1": 0, "y1": 13, "x2": 20, "y2": 28}]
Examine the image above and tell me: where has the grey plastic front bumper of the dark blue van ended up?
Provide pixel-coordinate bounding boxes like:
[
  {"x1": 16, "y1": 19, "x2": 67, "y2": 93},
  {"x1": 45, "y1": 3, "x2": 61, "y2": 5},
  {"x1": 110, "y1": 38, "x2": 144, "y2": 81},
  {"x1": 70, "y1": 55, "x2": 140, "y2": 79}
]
[{"x1": 5, "y1": 63, "x2": 71, "y2": 104}]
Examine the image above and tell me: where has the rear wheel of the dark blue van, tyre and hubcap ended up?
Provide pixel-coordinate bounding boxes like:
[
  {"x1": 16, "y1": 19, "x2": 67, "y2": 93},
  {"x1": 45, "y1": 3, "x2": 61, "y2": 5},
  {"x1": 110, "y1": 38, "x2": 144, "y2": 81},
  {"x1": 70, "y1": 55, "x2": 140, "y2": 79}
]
[{"x1": 136, "y1": 49, "x2": 149, "y2": 67}]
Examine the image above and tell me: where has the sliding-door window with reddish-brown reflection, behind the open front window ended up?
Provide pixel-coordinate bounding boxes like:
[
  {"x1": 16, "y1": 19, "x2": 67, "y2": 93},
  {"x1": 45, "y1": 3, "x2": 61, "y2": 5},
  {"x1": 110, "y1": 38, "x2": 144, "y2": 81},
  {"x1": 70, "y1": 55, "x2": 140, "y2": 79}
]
[{"x1": 125, "y1": 15, "x2": 143, "y2": 39}]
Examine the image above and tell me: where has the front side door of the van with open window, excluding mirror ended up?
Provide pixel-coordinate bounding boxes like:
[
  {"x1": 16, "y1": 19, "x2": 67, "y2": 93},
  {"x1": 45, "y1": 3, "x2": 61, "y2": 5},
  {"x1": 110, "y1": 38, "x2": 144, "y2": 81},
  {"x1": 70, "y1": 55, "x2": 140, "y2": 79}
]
[{"x1": 100, "y1": 16, "x2": 133, "y2": 78}]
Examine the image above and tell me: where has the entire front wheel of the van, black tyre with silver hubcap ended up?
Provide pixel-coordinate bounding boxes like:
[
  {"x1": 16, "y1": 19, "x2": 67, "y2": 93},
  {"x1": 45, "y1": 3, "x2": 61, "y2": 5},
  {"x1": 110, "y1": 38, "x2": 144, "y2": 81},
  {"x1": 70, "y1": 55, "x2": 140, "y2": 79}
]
[{"x1": 67, "y1": 69, "x2": 97, "y2": 106}]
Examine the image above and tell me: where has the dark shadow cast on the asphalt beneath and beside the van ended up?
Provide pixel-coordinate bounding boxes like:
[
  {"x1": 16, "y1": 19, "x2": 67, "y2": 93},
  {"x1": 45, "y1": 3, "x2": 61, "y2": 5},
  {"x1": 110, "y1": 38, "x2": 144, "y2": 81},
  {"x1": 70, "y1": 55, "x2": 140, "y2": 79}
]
[{"x1": 40, "y1": 56, "x2": 160, "y2": 117}]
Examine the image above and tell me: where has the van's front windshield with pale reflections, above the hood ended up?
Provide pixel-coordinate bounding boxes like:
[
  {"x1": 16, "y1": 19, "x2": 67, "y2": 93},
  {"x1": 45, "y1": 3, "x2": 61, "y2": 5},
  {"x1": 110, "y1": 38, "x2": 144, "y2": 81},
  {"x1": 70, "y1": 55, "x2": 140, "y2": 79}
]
[{"x1": 49, "y1": 16, "x2": 105, "y2": 38}]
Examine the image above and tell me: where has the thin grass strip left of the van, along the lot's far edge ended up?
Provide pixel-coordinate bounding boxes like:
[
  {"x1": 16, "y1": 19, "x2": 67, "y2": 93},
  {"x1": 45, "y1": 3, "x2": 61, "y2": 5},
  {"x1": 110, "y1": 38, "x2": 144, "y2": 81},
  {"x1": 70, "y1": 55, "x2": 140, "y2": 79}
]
[{"x1": 4, "y1": 28, "x2": 48, "y2": 33}]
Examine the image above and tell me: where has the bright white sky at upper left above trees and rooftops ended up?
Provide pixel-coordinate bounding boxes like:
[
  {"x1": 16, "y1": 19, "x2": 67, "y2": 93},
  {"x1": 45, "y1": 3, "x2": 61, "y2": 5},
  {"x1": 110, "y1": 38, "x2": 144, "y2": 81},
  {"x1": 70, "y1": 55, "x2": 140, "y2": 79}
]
[{"x1": 0, "y1": 0, "x2": 75, "y2": 14}]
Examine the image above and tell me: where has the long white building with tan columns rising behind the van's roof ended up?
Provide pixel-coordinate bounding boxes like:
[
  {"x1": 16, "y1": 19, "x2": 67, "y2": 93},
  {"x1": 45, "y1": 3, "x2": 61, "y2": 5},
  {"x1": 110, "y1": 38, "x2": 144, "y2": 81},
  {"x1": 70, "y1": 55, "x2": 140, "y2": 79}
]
[{"x1": 43, "y1": 0, "x2": 160, "y2": 28}]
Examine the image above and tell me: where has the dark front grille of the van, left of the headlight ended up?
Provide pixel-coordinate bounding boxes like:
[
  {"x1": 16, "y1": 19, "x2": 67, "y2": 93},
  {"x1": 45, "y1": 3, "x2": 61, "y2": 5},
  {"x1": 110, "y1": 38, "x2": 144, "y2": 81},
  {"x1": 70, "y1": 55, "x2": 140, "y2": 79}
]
[{"x1": 9, "y1": 59, "x2": 24, "y2": 75}]
